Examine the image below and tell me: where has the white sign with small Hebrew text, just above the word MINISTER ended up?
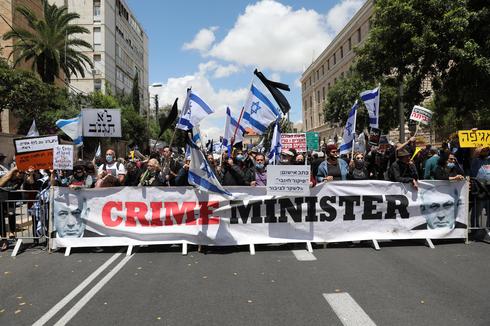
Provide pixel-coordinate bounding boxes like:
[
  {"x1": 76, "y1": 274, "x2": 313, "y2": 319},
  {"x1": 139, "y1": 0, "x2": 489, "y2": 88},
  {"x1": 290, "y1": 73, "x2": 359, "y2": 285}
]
[{"x1": 267, "y1": 165, "x2": 310, "y2": 196}]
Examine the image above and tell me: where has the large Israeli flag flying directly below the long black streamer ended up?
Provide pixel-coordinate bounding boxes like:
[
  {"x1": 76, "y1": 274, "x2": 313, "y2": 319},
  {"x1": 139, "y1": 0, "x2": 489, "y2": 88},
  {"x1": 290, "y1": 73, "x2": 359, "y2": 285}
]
[{"x1": 243, "y1": 84, "x2": 280, "y2": 135}]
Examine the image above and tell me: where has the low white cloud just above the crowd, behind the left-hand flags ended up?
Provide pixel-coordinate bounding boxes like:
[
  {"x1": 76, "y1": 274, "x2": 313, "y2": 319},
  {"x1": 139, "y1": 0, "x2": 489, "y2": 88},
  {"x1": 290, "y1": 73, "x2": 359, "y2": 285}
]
[{"x1": 150, "y1": 73, "x2": 248, "y2": 139}]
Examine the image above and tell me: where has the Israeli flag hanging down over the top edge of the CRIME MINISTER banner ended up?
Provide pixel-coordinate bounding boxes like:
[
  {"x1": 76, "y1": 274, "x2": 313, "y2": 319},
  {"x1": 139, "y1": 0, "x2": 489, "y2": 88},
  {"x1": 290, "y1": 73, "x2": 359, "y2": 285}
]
[{"x1": 187, "y1": 141, "x2": 233, "y2": 197}]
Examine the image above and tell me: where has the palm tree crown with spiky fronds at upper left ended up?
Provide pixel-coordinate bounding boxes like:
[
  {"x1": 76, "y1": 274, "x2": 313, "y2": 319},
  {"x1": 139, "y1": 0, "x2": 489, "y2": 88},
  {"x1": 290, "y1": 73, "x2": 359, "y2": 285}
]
[{"x1": 3, "y1": 0, "x2": 93, "y2": 84}]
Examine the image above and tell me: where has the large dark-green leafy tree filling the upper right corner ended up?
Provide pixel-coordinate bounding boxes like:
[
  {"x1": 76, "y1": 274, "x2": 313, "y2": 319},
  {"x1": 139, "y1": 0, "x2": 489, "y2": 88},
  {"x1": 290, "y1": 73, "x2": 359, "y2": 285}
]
[{"x1": 356, "y1": 0, "x2": 490, "y2": 135}]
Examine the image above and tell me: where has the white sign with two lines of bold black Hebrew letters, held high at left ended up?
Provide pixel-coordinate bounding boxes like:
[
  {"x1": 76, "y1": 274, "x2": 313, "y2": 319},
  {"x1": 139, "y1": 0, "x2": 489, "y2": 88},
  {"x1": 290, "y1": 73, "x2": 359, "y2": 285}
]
[{"x1": 82, "y1": 109, "x2": 121, "y2": 137}]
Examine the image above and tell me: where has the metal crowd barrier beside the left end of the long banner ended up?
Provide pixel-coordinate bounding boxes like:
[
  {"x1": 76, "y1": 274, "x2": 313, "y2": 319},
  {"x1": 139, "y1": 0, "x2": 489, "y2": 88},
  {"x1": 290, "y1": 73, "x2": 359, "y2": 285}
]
[{"x1": 0, "y1": 188, "x2": 49, "y2": 256}]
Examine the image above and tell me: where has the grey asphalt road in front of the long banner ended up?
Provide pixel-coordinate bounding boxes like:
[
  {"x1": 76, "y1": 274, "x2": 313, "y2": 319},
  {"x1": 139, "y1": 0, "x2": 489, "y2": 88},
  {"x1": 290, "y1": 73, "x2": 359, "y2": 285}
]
[{"x1": 0, "y1": 241, "x2": 490, "y2": 326}]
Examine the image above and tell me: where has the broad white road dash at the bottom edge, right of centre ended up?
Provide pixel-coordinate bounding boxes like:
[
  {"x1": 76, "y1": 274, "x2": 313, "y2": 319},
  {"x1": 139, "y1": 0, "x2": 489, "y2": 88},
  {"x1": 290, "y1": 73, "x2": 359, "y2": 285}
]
[{"x1": 323, "y1": 292, "x2": 376, "y2": 326}]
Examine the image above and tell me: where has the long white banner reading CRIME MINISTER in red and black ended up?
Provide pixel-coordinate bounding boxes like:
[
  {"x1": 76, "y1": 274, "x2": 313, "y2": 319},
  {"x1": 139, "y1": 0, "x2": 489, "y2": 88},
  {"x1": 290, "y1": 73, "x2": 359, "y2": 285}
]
[{"x1": 53, "y1": 180, "x2": 469, "y2": 247}]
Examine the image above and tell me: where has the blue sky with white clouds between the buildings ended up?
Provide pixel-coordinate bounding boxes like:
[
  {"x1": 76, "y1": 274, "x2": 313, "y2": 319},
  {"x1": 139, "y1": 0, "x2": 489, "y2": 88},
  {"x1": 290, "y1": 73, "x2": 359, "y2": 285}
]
[{"x1": 127, "y1": 0, "x2": 364, "y2": 139}]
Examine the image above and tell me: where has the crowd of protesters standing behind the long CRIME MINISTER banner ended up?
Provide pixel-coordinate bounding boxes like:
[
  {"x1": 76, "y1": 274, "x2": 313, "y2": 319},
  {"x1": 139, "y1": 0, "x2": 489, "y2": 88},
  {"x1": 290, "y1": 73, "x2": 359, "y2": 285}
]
[{"x1": 0, "y1": 131, "x2": 490, "y2": 250}]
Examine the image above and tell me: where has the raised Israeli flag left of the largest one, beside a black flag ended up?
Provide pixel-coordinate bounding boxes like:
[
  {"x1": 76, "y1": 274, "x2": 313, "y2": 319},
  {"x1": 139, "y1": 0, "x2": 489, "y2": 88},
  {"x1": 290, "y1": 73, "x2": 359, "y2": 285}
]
[{"x1": 176, "y1": 90, "x2": 214, "y2": 131}]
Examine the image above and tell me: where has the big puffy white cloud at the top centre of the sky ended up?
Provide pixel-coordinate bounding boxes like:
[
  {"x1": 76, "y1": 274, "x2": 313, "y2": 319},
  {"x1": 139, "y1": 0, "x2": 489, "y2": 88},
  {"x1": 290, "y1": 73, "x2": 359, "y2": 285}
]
[{"x1": 207, "y1": 0, "x2": 331, "y2": 72}]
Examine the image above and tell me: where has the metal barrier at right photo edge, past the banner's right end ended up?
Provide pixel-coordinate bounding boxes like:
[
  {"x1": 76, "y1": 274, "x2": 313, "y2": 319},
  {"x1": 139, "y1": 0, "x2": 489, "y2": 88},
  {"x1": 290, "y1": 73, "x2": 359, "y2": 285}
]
[{"x1": 469, "y1": 178, "x2": 490, "y2": 242}]
